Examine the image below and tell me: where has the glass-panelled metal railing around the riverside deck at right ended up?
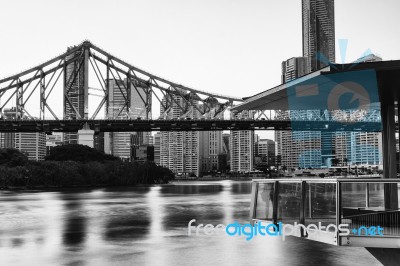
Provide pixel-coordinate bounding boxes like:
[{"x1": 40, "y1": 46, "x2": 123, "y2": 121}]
[{"x1": 250, "y1": 178, "x2": 400, "y2": 248}]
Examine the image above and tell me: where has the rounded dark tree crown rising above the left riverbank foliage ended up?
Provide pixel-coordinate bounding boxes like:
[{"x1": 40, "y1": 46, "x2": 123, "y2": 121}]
[{"x1": 45, "y1": 144, "x2": 119, "y2": 162}]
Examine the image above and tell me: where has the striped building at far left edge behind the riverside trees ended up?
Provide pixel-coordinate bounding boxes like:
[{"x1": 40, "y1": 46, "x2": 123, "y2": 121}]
[{"x1": 0, "y1": 107, "x2": 46, "y2": 161}]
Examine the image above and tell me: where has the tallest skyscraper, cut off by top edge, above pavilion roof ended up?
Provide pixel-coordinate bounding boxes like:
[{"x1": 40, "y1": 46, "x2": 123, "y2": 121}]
[{"x1": 302, "y1": 0, "x2": 335, "y2": 72}]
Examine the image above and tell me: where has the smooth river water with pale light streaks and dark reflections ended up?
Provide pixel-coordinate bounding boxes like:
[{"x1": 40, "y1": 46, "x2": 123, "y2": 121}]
[{"x1": 0, "y1": 181, "x2": 381, "y2": 266}]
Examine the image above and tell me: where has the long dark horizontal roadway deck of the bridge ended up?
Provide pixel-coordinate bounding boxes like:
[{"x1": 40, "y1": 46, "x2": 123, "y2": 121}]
[{"x1": 0, "y1": 119, "x2": 381, "y2": 133}]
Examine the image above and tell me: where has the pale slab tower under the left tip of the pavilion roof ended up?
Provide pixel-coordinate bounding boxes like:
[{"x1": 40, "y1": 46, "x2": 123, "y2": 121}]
[{"x1": 229, "y1": 111, "x2": 254, "y2": 172}]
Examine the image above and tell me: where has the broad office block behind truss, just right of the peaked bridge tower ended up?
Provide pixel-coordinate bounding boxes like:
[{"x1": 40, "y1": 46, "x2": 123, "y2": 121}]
[{"x1": 104, "y1": 79, "x2": 151, "y2": 160}]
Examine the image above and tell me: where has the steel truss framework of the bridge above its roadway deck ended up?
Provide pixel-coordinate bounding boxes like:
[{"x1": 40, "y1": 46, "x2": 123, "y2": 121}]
[{"x1": 0, "y1": 41, "x2": 243, "y2": 120}]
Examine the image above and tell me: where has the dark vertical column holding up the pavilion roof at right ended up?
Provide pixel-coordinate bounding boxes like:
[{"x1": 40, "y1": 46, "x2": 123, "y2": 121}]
[{"x1": 381, "y1": 95, "x2": 398, "y2": 210}]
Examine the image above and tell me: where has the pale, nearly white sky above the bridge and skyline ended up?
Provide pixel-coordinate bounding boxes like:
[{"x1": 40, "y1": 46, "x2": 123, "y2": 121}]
[{"x1": 0, "y1": 0, "x2": 400, "y2": 140}]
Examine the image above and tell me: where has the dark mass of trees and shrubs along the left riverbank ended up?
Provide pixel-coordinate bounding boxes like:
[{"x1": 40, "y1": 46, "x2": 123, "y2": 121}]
[{"x1": 0, "y1": 145, "x2": 174, "y2": 188}]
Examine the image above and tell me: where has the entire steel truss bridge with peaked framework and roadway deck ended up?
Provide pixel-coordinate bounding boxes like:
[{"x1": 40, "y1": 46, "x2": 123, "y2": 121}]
[{"x1": 0, "y1": 41, "x2": 380, "y2": 133}]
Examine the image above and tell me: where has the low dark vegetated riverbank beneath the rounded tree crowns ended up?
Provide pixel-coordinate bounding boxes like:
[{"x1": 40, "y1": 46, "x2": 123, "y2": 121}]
[{"x1": 0, "y1": 158, "x2": 174, "y2": 190}]
